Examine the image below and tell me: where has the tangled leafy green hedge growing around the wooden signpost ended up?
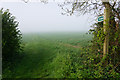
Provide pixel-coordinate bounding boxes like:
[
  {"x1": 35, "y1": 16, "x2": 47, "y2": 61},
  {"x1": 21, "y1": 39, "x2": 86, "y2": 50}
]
[{"x1": 89, "y1": 16, "x2": 120, "y2": 78}]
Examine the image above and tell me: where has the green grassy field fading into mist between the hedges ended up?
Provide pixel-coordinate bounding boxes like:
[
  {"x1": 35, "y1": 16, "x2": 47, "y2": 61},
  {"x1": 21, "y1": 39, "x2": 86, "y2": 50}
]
[{"x1": 4, "y1": 32, "x2": 92, "y2": 78}]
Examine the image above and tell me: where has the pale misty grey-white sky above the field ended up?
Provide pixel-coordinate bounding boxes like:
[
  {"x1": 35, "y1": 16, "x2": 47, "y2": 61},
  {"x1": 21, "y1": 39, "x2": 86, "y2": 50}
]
[{"x1": 2, "y1": 2, "x2": 93, "y2": 32}]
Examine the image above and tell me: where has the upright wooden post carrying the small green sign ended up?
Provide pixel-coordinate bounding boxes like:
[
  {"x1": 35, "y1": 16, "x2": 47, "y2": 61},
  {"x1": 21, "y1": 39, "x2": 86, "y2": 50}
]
[{"x1": 103, "y1": 4, "x2": 110, "y2": 57}]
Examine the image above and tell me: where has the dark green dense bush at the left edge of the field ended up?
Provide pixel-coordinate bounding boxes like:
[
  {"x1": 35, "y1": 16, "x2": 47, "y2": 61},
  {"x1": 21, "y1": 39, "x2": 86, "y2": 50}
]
[{"x1": 0, "y1": 9, "x2": 22, "y2": 72}]
